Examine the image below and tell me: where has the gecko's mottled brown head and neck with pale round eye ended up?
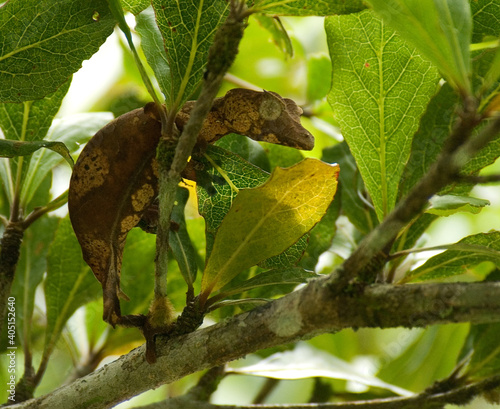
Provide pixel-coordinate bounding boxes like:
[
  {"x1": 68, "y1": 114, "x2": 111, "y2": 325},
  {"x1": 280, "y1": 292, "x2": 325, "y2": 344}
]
[{"x1": 175, "y1": 88, "x2": 314, "y2": 150}]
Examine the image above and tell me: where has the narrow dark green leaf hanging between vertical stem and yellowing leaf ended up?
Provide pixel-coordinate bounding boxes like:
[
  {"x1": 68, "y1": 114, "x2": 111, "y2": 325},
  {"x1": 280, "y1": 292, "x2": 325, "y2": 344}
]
[{"x1": 169, "y1": 187, "x2": 198, "y2": 288}]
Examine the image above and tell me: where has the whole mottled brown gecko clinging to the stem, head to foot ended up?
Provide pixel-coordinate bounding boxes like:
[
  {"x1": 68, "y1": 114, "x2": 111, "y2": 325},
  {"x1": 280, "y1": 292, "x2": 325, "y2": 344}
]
[{"x1": 68, "y1": 89, "x2": 314, "y2": 327}]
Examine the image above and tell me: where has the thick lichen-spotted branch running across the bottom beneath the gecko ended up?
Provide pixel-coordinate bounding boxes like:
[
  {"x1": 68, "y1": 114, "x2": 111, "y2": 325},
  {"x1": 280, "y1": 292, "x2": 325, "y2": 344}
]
[{"x1": 12, "y1": 277, "x2": 500, "y2": 409}]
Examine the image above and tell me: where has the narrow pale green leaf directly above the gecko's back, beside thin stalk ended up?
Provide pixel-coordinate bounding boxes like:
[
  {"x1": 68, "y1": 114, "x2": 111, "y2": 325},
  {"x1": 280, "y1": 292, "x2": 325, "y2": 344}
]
[{"x1": 135, "y1": 8, "x2": 172, "y2": 99}]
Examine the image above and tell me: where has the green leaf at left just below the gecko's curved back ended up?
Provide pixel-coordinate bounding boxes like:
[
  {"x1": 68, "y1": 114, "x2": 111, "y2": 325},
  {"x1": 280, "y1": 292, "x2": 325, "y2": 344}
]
[{"x1": 44, "y1": 217, "x2": 101, "y2": 357}]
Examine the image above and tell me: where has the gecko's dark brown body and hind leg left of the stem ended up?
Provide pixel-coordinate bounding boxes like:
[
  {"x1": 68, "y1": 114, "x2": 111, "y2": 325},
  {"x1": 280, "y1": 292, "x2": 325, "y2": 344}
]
[{"x1": 68, "y1": 103, "x2": 161, "y2": 325}]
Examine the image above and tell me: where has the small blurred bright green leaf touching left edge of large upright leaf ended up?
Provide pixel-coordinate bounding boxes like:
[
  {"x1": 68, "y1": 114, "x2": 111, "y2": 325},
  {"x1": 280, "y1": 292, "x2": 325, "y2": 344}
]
[{"x1": 307, "y1": 53, "x2": 332, "y2": 102}]
